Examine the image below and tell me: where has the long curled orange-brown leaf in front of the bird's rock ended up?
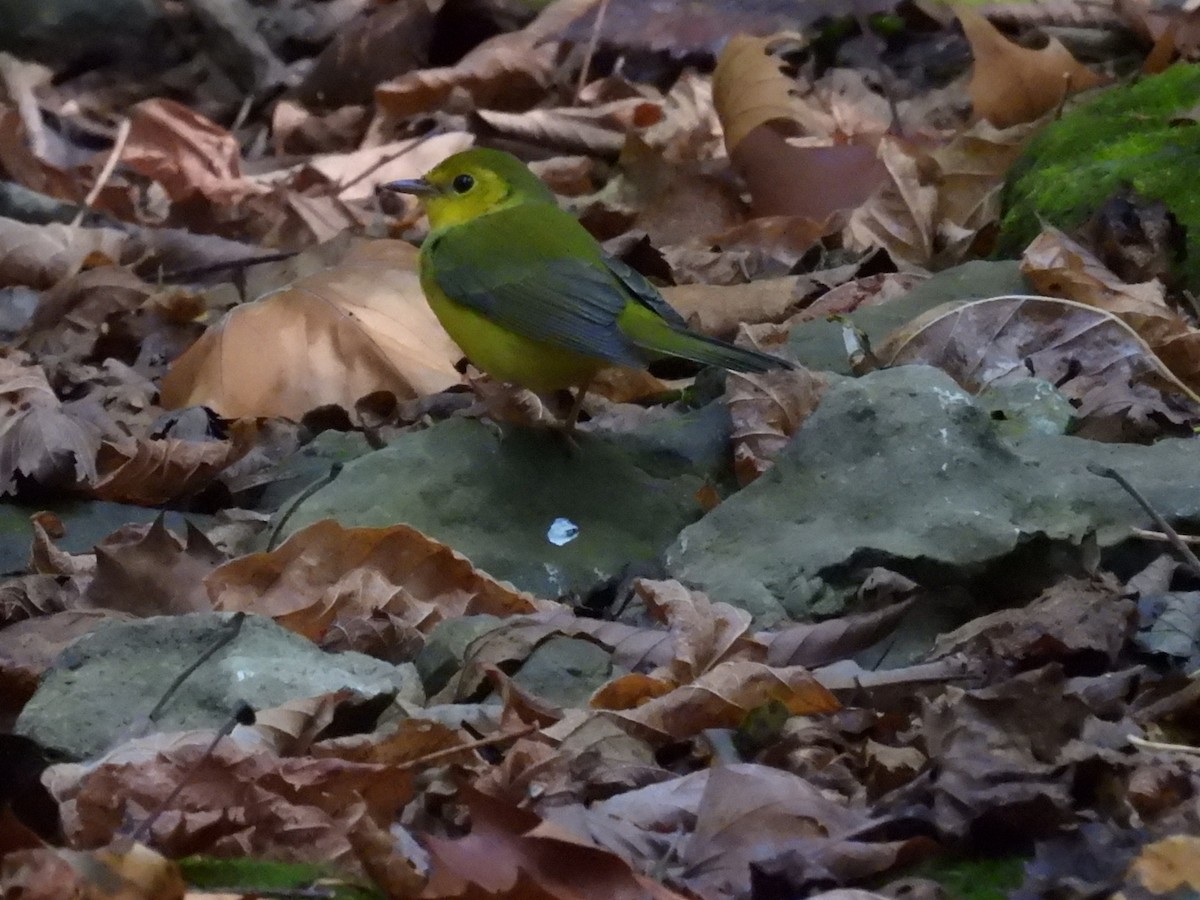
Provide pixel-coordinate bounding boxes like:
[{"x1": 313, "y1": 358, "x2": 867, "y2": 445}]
[{"x1": 204, "y1": 520, "x2": 557, "y2": 641}]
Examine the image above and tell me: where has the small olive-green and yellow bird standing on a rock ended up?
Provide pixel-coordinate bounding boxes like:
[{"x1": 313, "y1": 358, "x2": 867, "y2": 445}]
[{"x1": 383, "y1": 148, "x2": 794, "y2": 433}]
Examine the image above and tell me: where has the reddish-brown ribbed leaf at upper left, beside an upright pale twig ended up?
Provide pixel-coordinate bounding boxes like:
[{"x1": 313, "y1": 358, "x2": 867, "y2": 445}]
[{"x1": 121, "y1": 98, "x2": 263, "y2": 206}]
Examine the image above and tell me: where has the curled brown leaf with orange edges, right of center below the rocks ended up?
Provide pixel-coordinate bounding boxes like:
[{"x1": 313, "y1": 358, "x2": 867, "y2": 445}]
[{"x1": 592, "y1": 661, "x2": 841, "y2": 740}]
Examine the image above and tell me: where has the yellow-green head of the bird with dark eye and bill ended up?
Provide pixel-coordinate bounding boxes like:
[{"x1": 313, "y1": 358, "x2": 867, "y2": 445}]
[{"x1": 383, "y1": 148, "x2": 554, "y2": 230}]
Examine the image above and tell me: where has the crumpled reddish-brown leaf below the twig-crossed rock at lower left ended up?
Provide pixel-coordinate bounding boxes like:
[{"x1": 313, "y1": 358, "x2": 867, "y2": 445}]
[{"x1": 43, "y1": 732, "x2": 413, "y2": 888}]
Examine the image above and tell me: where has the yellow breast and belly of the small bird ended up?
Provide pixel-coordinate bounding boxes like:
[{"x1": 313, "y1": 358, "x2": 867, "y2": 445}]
[{"x1": 421, "y1": 266, "x2": 608, "y2": 394}]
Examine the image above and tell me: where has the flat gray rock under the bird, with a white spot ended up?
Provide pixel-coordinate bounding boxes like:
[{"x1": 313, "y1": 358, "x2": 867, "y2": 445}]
[{"x1": 286, "y1": 404, "x2": 730, "y2": 598}]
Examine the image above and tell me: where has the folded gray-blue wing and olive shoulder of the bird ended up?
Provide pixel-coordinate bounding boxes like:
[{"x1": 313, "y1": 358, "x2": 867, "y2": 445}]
[{"x1": 426, "y1": 204, "x2": 661, "y2": 366}]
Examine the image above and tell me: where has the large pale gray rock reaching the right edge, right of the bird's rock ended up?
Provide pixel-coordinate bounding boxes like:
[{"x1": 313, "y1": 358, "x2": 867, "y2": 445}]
[{"x1": 666, "y1": 366, "x2": 1200, "y2": 624}]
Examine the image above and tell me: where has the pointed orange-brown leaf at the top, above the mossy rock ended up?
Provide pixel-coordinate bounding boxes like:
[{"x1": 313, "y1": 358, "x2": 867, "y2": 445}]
[{"x1": 955, "y1": 5, "x2": 1108, "y2": 128}]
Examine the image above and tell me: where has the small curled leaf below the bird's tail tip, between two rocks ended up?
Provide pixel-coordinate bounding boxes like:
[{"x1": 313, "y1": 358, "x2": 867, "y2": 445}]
[{"x1": 725, "y1": 367, "x2": 828, "y2": 486}]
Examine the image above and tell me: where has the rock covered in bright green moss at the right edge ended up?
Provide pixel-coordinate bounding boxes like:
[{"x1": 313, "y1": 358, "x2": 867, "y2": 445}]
[{"x1": 997, "y1": 64, "x2": 1200, "y2": 290}]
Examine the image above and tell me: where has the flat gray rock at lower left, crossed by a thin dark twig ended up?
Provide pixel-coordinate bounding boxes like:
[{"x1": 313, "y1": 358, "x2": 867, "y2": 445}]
[{"x1": 16, "y1": 613, "x2": 425, "y2": 760}]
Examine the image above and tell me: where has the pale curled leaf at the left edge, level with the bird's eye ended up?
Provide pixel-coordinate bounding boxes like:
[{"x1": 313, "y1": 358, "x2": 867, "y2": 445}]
[{"x1": 0, "y1": 217, "x2": 128, "y2": 289}]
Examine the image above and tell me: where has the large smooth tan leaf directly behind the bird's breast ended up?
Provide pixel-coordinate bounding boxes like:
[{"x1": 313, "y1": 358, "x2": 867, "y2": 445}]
[{"x1": 162, "y1": 240, "x2": 462, "y2": 419}]
